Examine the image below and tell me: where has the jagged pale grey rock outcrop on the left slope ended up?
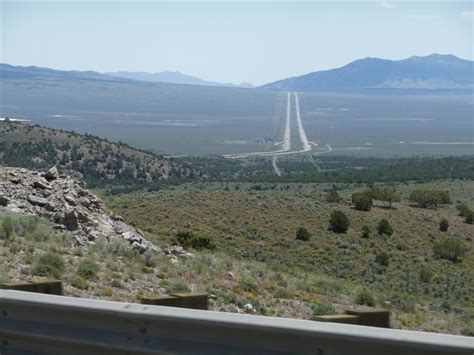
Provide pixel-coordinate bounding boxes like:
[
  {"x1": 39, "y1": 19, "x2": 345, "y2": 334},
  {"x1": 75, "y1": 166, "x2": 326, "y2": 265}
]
[{"x1": 0, "y1": 167, "x2": 160, "y2": 253}]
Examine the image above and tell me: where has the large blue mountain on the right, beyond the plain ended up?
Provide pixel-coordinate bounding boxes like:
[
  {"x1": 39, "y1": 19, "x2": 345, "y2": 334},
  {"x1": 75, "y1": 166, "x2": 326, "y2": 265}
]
[{"x1": 261, "y1": 54, "x2": 474, "y2": 91}]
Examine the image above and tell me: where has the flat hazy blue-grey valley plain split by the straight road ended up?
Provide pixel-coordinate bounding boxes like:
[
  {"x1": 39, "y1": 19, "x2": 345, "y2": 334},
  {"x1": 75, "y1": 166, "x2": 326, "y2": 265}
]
[{"x1": 0, "y1": 63, "x2": 473, "y2": 159}]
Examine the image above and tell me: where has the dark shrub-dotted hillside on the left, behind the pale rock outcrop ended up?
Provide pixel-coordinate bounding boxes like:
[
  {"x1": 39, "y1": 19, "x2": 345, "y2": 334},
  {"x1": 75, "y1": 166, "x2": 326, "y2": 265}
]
[{"x1": 0, "y1": 120, "x2": 203, "y2": 186}]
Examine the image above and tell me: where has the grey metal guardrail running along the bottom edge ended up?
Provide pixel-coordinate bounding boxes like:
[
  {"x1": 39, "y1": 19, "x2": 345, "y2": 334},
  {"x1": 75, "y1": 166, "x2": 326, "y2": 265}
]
[{"x1": 0, "y1": 290, "x2": 474, "y2": 355}]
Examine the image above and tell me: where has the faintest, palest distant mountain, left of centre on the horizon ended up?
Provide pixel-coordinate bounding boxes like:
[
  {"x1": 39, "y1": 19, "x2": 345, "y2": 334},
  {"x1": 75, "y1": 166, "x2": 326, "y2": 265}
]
[{"x1": 105, "y1": 71, "x2": 255, "y2": 89}]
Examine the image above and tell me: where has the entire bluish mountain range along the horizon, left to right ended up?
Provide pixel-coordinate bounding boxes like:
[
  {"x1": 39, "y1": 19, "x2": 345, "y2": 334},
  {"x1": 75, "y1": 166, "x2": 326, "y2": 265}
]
[{"x1": 0, "y1": 54, "x2": 474, "y2": 92}]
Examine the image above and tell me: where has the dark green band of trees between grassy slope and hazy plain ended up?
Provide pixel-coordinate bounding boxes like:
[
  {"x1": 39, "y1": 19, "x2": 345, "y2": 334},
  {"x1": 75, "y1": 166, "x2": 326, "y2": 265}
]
[{"x1": 107, "y1": 156, "x2": 474, "y2": 195}]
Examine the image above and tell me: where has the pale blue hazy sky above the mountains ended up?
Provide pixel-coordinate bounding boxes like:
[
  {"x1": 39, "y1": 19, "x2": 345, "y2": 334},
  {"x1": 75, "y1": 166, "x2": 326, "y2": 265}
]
[{"x1": 0, "y1": 0, "x2": 474, "y2": 84}]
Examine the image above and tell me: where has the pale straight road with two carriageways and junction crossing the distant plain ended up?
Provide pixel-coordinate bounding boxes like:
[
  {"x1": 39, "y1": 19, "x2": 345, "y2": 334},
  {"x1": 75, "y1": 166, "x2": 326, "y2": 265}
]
[{"x1": 223, "y1": 92, "x2": 332, "y2": 176}]
